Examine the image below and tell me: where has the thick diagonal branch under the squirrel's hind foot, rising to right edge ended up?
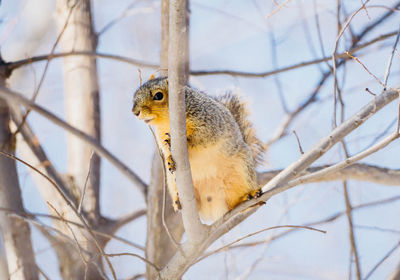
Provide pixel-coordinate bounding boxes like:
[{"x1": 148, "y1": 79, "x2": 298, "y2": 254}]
[{"x1": 160, "y1": 89, "x2": 399, "y2": 279}]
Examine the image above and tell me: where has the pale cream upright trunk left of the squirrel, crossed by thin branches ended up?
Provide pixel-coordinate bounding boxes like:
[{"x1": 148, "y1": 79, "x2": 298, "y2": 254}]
[{"x1": 57, "y1": 0, "x2": 100, "y2": 225}]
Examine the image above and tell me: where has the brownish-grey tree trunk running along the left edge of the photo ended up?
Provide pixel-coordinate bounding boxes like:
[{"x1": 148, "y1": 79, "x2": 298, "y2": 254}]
[{"x1": 0, "y1": 77, "x2": 38, "y2": 280}]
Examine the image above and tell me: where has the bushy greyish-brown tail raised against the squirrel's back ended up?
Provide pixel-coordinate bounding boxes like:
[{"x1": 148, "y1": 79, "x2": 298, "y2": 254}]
[{"x1": 215, "y1": 92, "x2": 267, "y2": 164}]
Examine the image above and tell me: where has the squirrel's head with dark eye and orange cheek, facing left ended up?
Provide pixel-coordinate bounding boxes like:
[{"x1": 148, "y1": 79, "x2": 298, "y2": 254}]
[{"x1": 132, "y1": 77, "x2": 169, "y2": 124}]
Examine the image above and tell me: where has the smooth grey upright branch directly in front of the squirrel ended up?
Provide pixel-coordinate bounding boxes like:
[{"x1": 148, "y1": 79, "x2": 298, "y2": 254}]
[{"x1": 168, "y1": 0, "x2": 205, "y2": 242}]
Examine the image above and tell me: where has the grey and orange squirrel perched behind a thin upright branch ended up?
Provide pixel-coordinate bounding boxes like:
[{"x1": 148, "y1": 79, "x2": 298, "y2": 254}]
[{"x1": 132, "y1": 77, "x2": 266, "y2": 221}]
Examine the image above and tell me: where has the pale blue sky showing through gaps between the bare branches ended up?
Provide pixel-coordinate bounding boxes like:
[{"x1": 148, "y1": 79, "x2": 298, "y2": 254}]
[{"x1": 0, "y1": 0, "x2": 400, "y2": 279}]
